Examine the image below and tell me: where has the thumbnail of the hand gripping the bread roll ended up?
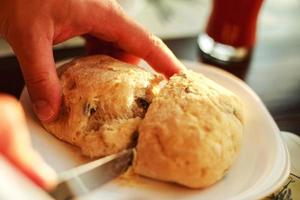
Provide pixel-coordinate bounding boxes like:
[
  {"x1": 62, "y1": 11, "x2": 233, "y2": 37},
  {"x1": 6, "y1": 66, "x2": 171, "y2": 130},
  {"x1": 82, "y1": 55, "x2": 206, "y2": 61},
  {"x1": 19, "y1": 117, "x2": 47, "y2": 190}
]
[{"x1": 33, "y1": 100, "x2": 54, "y2": 121}]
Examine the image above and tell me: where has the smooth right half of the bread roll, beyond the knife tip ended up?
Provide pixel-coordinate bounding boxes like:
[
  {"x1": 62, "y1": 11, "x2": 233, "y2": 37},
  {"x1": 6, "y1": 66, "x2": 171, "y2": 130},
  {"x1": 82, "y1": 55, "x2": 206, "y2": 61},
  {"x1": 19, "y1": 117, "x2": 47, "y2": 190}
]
[{"x1": 133, "y1": 70, "x2": 243, "y2": 188}]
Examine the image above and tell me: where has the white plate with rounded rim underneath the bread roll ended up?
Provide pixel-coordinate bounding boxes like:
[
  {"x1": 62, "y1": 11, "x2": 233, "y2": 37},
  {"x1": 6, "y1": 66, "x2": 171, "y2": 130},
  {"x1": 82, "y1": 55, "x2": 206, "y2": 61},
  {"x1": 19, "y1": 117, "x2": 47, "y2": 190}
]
[{"x1": 21, "y1": 62, "x2": 290, "y2": 200}]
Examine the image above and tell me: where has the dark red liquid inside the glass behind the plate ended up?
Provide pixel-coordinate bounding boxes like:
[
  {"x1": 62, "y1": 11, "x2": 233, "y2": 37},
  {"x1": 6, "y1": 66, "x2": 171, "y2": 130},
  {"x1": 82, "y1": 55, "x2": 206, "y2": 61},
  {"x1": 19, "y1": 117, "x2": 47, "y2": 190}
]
[{"x1": 206, "y1": 0, "x2": 263, "y2": 48}]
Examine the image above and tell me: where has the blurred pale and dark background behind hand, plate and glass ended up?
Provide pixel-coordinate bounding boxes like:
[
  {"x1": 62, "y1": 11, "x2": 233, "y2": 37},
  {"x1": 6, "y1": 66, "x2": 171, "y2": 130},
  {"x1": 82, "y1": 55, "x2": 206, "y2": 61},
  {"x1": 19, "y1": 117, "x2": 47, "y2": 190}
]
[{"x1": 0, "y1": 0, "x2": 300, "y2": 134}]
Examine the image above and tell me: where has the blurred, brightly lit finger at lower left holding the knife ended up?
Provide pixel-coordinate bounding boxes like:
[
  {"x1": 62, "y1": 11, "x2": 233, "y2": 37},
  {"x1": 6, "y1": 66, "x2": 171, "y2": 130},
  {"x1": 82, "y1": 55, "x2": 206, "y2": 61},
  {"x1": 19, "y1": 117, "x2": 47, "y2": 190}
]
[{"x1": 0, "y1": 94, "x2": 56, "y2": 189}]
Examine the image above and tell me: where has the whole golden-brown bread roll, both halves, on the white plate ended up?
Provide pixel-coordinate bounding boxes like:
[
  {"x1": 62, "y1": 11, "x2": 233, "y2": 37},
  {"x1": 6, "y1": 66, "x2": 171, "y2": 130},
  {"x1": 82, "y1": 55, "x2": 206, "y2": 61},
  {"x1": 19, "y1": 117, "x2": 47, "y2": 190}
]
[{"x1": 43, "y1": 55, "x2": 243, "y2": 188}]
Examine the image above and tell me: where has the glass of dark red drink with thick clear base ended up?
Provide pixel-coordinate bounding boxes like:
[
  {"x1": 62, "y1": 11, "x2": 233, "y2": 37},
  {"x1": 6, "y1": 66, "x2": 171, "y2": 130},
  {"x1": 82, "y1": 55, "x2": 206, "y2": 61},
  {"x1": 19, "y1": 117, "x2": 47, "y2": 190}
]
[{"x1": 198, "y1": 0, "x2": 263, "y2": 62}]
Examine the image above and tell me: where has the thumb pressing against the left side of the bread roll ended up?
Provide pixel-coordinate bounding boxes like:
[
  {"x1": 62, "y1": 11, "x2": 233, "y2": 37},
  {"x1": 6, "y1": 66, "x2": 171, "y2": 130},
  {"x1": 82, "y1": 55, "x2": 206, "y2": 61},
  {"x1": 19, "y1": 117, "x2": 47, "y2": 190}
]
[{"x1": 11, "y1": 37, "x2": 61, "y2": 122}]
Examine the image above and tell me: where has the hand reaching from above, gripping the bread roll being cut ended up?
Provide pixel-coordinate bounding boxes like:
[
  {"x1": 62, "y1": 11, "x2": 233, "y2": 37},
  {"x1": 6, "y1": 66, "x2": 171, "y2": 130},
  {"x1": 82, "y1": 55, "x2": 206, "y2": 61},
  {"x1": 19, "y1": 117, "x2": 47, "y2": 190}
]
[{"x1": 0, "y1": 0, "x2": 184, "y2": 122}]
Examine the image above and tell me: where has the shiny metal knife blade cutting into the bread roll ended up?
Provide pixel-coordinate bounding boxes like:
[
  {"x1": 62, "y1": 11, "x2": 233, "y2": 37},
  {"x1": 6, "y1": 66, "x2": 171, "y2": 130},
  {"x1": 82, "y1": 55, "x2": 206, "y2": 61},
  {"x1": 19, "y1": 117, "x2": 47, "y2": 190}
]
[{"x1": 49, "y1": 149, "x2": 133, "y2": 200}]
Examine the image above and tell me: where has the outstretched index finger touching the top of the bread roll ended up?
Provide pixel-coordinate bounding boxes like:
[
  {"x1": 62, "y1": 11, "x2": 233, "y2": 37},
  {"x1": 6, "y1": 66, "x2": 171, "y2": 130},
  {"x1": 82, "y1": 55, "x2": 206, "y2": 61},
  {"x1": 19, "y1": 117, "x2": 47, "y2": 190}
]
[{"x1": 88, "y1": 1, "x2": 185, "y2": 77}]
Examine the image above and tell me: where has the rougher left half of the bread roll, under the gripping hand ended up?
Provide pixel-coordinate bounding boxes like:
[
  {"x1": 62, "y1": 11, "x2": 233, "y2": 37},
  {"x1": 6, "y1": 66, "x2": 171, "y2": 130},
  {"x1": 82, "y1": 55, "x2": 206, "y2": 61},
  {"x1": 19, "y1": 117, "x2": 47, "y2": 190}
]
[{"x1": 43, "y1": 56, "x2": 161, "y2": 157}]
